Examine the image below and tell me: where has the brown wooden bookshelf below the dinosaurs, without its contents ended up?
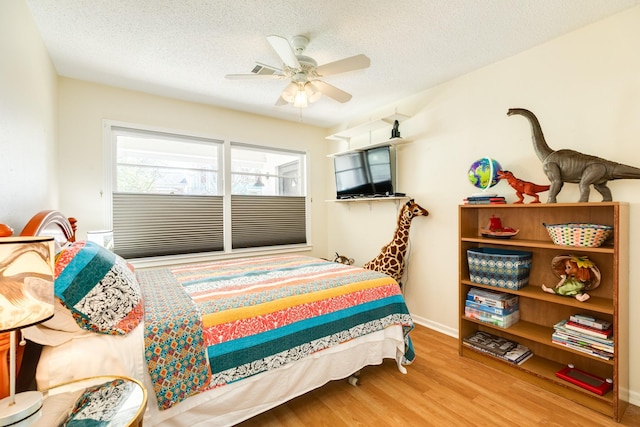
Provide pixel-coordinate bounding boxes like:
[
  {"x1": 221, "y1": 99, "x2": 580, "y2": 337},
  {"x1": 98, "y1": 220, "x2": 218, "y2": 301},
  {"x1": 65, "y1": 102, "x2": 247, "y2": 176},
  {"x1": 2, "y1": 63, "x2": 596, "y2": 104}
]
[{"x1": 459, "y1": 202, "x2": 629, "y2": 421}]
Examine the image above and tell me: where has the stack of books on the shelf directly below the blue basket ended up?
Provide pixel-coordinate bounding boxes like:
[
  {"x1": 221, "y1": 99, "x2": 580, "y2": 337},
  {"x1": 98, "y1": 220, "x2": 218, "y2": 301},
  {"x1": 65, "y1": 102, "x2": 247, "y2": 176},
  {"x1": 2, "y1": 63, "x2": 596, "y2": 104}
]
[{"x1": 464, "y1": 288, "x2": 520, "y2": 328}]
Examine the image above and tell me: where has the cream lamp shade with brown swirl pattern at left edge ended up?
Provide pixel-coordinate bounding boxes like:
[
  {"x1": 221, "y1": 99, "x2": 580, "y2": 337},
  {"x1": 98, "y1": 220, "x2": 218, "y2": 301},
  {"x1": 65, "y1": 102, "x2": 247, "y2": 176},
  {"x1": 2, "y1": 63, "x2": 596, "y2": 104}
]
[{"x1": 0, "y1": 236, "x2": 55, "y2": 331}]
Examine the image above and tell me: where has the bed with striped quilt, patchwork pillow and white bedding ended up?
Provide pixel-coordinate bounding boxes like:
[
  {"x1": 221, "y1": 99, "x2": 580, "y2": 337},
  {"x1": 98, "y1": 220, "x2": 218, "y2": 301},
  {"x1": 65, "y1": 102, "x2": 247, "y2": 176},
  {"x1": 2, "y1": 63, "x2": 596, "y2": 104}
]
[{"x1": 15, "y1": 211, "x2": 414, "y2": 426}]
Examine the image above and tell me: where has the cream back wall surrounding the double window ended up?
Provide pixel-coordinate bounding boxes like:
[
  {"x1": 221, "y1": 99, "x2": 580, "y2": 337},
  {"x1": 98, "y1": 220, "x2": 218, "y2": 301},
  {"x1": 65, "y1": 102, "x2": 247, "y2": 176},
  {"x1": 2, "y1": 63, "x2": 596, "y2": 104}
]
[{"x1": 59, "y1": 78, "x2": 327, "y2": 257}]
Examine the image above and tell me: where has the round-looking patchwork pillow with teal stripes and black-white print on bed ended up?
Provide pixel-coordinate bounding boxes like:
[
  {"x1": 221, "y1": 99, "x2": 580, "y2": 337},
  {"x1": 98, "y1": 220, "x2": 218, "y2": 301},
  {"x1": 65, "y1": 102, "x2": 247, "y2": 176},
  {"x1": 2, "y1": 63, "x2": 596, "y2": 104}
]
[{"x1": 55, "y1": 241, "x2": 143, "y2": 335}]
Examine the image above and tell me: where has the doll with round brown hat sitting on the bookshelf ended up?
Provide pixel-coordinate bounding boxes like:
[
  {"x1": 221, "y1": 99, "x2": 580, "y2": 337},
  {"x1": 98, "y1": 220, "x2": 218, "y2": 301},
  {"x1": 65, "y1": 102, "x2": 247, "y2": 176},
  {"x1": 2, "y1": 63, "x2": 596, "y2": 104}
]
[{"x1": 542, "y1": 255, "x2": 601, "y2": 302}]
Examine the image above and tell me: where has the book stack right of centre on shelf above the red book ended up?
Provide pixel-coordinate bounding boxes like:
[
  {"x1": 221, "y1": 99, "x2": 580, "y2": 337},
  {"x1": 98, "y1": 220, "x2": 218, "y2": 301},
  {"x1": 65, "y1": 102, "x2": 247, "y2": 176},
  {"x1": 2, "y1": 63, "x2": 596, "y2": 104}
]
[{"x1": 551, "y1": 314, "x2": 614, "y2": 360}]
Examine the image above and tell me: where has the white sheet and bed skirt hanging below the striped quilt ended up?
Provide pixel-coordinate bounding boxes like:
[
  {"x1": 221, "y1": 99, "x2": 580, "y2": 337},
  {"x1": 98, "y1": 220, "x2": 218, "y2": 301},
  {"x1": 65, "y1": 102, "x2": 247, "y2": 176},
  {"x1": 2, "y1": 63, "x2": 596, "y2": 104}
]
[{"x1": 36, "y1": 324, "x2": 404, "y2": 427}]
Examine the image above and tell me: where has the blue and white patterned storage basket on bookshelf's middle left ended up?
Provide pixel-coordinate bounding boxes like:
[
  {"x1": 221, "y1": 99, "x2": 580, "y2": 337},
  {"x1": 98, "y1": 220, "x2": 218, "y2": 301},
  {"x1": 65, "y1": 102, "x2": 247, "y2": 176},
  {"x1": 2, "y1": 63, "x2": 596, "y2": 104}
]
[{"x1": 467, "y1": 248, "x2": 531, "y2": 290}]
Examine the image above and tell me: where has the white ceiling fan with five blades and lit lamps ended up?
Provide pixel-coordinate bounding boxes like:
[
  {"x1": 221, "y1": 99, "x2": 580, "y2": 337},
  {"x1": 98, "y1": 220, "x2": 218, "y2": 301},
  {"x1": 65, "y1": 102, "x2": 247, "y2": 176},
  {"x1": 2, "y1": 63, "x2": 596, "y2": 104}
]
[{"x1": 225, "y1": 35, "x2": 371, "y2": 107}]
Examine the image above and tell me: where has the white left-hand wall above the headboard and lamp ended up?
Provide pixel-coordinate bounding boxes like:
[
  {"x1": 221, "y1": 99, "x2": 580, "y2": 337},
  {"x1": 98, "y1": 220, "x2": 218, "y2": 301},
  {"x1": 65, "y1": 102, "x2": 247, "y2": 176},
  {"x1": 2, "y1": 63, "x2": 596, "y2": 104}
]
[{"x1": 0, "y1": 1, "x2": 58, "y2": 234}]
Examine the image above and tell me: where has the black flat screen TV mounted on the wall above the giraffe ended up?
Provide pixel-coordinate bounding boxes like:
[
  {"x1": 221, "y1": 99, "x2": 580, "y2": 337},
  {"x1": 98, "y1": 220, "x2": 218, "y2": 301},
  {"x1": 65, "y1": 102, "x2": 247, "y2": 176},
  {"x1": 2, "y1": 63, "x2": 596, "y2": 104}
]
[{"x1": 333, "y1": 146, "x2": 395, "y2": 199}]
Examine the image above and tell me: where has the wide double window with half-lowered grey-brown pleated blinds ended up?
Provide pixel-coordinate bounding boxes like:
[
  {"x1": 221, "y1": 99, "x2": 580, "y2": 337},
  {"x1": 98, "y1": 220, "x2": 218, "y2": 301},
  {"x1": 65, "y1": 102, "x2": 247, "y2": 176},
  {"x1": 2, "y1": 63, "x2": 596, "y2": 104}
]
[{"x1": 110, "y1": 126, "x2": 307, "y2": 258}]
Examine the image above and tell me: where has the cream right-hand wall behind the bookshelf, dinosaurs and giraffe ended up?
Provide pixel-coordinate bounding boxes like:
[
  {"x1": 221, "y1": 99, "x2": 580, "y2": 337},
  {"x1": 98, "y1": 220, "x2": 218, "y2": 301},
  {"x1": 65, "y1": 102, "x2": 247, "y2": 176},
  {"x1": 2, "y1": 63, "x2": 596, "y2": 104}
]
[{"x1": 328, "y1": 7, "x2": 640, "y2": 405}]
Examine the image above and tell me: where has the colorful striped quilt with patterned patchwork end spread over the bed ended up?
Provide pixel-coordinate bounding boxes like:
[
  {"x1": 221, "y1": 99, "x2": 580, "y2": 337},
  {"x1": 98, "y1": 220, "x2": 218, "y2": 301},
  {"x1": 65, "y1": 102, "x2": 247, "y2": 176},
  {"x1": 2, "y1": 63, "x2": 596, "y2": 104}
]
[{"x1": 138, "y1": 255, "x2": 413, "y2": 409}]
